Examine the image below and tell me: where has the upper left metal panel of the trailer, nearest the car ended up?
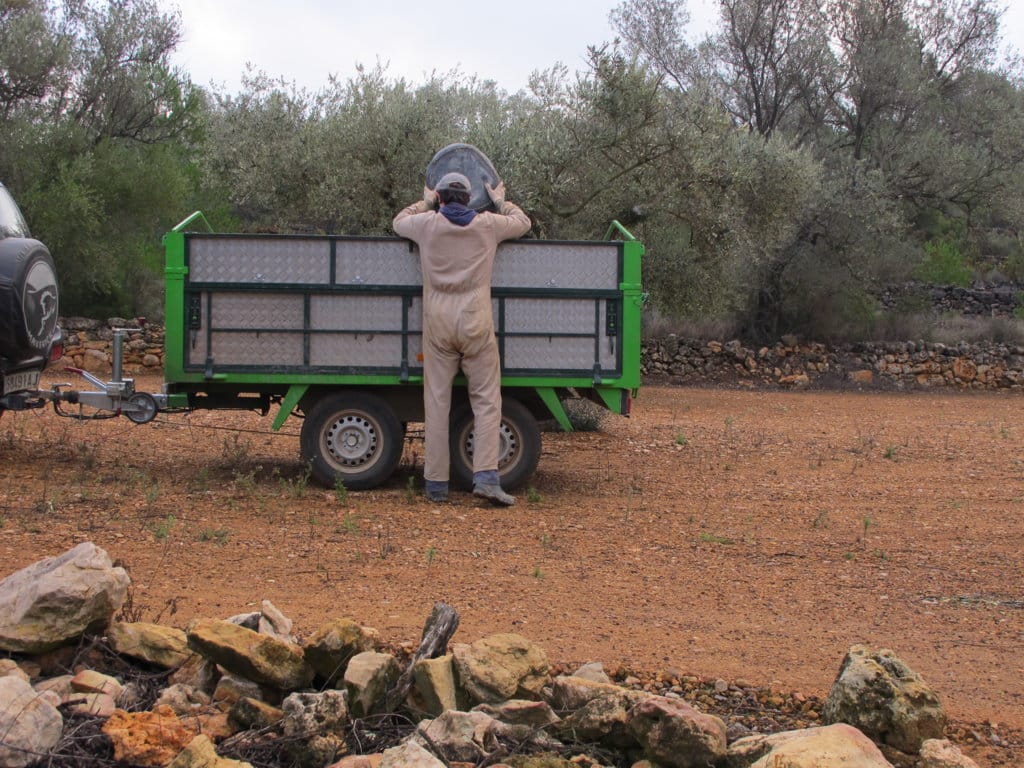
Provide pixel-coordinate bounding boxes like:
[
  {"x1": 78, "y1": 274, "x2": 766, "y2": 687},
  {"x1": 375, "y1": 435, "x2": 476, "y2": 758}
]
[{"x1": 188, "y1": 236, "x2": 331, "y2": 285}]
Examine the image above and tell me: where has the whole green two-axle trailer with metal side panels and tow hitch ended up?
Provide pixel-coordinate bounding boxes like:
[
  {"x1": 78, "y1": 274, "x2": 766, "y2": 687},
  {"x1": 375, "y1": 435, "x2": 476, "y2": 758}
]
[{"x1": 48, "y1": 212, "x2": 643, "y2": 489}]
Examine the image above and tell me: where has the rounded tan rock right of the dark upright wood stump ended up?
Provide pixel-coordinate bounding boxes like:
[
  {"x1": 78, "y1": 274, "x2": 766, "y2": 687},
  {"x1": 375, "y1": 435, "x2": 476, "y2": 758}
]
[{"x1": 453, "y1": 634, "x2": 548, "y2": 703}]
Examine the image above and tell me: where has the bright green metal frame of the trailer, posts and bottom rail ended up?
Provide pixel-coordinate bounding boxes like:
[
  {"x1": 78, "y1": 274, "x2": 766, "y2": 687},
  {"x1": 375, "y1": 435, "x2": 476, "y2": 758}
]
[{"x1": 163, "y1": 217, "x2": 644, "y2": 431}]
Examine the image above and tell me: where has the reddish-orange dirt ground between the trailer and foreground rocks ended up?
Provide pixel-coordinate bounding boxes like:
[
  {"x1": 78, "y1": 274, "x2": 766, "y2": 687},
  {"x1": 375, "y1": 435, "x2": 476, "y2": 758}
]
[{"x1": 0, "y1": 379, "x2": 1024, "y2": 765}]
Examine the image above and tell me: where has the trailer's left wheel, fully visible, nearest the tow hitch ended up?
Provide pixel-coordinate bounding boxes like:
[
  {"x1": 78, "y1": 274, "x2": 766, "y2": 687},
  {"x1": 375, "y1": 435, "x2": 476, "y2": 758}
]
[{"x1": 299, "y1": 392, "x2": 402, "y2": 490}]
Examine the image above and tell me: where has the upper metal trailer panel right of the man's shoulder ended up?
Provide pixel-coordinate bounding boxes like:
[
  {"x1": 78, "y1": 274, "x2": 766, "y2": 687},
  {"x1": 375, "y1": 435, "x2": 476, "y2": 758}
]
[{"x1": 492, "y1": 241, "x2": 618, "y2": 291}]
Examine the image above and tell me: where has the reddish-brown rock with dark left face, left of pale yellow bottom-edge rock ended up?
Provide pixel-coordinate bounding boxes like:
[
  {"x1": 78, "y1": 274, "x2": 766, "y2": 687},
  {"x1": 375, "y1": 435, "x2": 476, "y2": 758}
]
[{"x1": 627, "y1": 696, "x2": 726, "y2": 768}]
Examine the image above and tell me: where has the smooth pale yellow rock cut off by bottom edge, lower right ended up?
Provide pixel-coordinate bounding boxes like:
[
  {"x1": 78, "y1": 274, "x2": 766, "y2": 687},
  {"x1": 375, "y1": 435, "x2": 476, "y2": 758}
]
[{"x1": 728, "y1": 724, "x2": 892, "y2": 768}]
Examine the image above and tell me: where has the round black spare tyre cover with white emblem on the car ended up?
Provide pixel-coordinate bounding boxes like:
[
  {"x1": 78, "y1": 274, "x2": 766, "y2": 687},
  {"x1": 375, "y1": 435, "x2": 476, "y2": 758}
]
[{"x1": 0, "y1": 238, "x2": 59, "y2": 360}]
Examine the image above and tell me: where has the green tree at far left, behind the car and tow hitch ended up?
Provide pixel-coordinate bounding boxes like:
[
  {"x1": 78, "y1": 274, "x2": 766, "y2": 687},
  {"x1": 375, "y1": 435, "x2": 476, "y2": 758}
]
[{"x1": 0, "y1": 0, "x2": 201, "y2": 316}]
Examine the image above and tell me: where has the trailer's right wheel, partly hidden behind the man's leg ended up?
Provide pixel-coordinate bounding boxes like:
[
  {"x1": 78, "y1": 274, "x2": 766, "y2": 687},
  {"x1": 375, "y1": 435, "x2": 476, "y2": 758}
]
[{"x1": 449, "y1": 395, "x2": 541, "y2": 489}]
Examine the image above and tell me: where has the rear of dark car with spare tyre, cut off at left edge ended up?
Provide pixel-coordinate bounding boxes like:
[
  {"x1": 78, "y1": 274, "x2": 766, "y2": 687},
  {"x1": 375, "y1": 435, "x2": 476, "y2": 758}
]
[{"x1": 0, "y1": 183, "x2": 63, "y2": 415}]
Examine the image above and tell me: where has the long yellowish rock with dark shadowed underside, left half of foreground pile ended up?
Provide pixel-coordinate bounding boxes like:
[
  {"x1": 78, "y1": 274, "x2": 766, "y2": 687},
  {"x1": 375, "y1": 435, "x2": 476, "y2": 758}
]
[{"x1": 186, "y1": 618, "x2": 313, "y2": 690}]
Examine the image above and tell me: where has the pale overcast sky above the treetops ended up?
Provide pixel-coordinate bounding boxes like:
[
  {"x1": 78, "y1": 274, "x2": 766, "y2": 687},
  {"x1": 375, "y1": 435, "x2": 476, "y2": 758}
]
[{"x1": 159, "y1": 0, "x2": 1024, "y2": 93}]
